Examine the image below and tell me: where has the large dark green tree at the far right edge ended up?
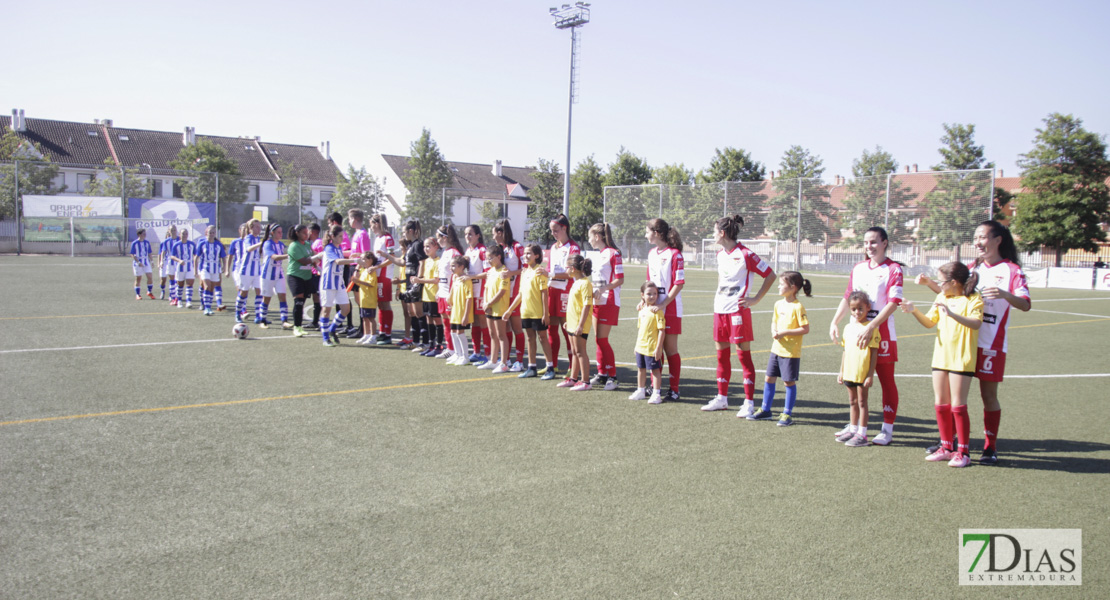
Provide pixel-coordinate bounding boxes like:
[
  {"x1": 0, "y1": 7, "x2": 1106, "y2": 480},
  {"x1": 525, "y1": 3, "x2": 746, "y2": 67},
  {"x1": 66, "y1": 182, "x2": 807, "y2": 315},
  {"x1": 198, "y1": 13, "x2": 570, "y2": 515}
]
[{"x1": 1013, "y1": 113, "x2": 1110, "y2": 266}]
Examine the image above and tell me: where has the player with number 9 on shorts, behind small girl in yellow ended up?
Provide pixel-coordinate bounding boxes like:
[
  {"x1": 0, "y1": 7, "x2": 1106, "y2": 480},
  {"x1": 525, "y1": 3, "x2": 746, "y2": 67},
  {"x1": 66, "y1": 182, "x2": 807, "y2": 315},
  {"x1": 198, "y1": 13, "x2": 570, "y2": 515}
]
[{"x1": 829, "y1": 227, "x2": 902, "y2": 446}]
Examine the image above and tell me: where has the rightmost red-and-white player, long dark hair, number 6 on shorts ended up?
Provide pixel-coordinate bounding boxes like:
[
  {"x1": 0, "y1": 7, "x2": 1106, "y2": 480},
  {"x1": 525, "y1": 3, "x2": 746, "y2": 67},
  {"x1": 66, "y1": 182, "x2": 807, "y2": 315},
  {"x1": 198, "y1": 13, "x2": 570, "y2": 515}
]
[{"x1": 917, "y1": 221, "x2": 1032, "y2": 465}]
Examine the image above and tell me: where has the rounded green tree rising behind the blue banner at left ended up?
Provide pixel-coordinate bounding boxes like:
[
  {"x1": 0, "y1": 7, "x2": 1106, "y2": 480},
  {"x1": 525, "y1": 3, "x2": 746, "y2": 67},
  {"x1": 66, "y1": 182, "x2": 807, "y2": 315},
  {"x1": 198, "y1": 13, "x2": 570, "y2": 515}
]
[{"x1": 169, "y1": 139, "x2": 250, "y2": 204}]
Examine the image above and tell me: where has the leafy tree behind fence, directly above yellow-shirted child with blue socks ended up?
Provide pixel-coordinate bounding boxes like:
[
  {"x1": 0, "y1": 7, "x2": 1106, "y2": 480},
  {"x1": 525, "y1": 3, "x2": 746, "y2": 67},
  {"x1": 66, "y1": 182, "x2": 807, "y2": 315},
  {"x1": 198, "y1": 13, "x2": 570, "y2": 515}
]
[{"x1": 766, "y1": 145, "x2": 833, "y2": 242}]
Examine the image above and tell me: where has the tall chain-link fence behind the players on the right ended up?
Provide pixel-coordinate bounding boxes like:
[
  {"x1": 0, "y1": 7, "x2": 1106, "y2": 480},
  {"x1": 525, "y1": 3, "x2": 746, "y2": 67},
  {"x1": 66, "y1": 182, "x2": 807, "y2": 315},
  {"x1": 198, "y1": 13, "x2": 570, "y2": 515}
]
[{"x1": 604, "y1": 170, "x2": 993, "y2": 273}]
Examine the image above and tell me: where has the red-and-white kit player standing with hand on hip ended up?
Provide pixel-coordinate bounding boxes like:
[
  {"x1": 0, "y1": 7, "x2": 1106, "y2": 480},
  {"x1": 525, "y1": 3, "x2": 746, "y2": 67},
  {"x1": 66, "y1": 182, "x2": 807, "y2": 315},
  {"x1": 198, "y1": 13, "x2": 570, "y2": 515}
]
[{"x1": 702, "y1": 215, "x2": 776, "y2": 418}]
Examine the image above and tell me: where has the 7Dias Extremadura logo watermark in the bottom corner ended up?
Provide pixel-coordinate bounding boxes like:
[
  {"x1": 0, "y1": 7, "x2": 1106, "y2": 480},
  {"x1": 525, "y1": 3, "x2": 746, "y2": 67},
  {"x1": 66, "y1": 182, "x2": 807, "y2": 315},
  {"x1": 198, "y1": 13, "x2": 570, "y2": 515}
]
[{"x1": 959, "y1": 529, "x2": 1083, "y2": 586}]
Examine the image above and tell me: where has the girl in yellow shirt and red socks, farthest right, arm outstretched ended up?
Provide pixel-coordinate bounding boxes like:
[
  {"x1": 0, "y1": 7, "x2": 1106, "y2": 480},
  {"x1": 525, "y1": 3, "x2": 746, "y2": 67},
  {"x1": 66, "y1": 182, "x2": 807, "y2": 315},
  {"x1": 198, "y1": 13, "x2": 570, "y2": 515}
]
[{"x1": 902, "y1": 262, "x2": 982, "y2": 467}]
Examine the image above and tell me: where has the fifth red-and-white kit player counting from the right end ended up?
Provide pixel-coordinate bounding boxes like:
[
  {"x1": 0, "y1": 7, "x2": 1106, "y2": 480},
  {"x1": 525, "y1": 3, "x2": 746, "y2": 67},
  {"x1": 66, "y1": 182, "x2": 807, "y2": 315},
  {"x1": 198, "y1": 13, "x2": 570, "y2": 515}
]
[{"x1": 589, "y1": 223, "x2": 624, "y2": 390}]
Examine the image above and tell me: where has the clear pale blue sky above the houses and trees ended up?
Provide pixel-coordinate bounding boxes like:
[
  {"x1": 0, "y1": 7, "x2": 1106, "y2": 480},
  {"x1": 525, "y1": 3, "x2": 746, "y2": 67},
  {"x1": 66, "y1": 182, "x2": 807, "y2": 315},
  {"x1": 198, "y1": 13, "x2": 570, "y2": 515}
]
[{"x1": 8, "y1": 0, "x2": 1110, "y2": 180}]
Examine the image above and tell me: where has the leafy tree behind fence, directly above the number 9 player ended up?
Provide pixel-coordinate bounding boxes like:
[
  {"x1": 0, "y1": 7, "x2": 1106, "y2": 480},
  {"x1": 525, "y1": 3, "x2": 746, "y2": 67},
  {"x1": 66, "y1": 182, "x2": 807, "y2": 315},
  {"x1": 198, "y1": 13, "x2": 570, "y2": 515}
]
[{"x1": 840, "y1": 146, "x2": 914, "y2": 245}]
